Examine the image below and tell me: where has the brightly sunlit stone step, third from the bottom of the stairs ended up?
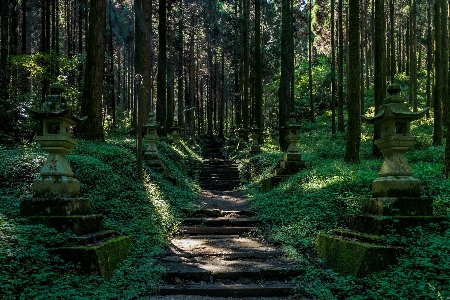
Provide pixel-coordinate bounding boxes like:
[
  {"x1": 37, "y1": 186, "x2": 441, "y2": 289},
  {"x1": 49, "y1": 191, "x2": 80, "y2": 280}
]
[{"x1": 163, "y1": 235, "x2": 284, "y2": 262}]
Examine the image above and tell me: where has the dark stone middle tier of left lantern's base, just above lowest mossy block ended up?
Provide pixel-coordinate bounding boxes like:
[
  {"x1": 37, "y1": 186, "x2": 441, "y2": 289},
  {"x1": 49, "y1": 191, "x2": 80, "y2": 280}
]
[{"x1": 28, "y1": 215, "x2": 103, "y2": 235}]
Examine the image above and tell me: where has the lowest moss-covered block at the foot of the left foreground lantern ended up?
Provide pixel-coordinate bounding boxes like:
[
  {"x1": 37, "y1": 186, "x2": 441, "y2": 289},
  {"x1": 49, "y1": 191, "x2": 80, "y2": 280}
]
[{"x1": 54, "y1": 236, "x2": 131, "y2": 279}]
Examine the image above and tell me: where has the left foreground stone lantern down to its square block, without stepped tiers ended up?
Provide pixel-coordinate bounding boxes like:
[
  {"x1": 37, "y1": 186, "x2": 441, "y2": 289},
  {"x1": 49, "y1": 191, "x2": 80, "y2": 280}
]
[{"x1": 27, "y1": 83, "x2": 86, "y2": 197}]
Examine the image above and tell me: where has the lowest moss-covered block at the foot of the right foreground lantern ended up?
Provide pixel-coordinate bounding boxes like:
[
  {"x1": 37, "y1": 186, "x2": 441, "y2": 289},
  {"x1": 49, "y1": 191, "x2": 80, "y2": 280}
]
[{"x1": 316, "y1": 234, "x2": 401, "y2": 277}]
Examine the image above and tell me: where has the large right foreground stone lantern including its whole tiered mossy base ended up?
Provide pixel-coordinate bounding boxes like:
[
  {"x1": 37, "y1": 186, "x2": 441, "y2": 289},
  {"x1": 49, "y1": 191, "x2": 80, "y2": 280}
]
[{"x1": 316, "y1": 84, "x2": 448, "y2": 276}]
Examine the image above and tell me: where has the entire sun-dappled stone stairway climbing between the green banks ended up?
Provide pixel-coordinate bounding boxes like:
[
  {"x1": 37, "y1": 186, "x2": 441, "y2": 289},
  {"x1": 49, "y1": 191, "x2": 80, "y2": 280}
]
[{"x1": 159, "y1": 142, "x2": 300, "y2": 297}]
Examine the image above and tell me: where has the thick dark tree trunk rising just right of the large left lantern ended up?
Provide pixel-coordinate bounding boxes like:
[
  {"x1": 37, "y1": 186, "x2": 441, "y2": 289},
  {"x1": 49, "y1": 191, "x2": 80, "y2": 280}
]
[{"x1": 80, "y1": 0, "x2": 106, "y2": 140}]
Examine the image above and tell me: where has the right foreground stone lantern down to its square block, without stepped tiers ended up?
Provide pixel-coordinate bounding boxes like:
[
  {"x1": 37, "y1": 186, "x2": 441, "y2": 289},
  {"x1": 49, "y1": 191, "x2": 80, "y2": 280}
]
[{"x1": 362, "y1": 84, "x2": 429, "y2": 197}]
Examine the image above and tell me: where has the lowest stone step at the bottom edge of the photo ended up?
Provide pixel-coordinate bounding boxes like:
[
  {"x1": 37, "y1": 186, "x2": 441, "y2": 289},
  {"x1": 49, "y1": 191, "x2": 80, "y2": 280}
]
[{"x1": 159, "y1": 283, "x2": 298, "y2": 298}]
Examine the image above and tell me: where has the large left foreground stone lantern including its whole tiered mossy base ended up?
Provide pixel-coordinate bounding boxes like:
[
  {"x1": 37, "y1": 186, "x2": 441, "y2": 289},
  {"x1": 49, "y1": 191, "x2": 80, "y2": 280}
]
[{"x1": 20, "y1": 83, "x2": 131, "y2": 278}]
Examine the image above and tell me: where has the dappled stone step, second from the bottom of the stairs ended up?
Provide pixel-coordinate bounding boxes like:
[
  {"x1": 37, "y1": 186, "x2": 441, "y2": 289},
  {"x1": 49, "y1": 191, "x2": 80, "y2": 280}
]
[{"x1": 162, "y1": 256, "x2": 302, "y2": 283}]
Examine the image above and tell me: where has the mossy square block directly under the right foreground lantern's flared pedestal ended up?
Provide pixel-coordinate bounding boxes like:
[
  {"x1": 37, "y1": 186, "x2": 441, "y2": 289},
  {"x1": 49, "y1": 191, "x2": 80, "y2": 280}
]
[{"x1": 372, "y1": 176, "x2": 421, "y2": 198}]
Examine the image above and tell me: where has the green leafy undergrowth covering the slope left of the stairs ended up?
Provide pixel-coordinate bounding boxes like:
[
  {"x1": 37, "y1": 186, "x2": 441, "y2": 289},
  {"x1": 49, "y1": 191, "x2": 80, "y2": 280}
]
[{"x1": 0, "y1": 137, "x2": 200, "y2": 299}]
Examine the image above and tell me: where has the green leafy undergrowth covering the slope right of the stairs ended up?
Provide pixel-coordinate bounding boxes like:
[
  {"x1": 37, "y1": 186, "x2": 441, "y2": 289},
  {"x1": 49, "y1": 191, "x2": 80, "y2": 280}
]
[{"x1": 235, "y1": 115, "x2": 450, "y2": 299}]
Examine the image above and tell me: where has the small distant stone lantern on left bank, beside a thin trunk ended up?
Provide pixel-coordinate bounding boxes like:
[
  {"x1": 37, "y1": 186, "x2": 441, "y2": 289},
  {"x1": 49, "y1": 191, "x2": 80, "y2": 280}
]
[{"x1": 144, "y1": 112, "x2": 164, "y2": 172}]
